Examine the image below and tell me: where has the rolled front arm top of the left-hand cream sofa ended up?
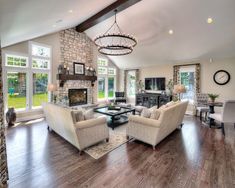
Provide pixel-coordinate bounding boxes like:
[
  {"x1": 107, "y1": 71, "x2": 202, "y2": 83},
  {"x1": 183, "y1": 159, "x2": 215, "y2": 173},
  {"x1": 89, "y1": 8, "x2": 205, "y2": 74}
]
[{"x1": 74, "y1": 116, "x2": 107, "y2": 129}]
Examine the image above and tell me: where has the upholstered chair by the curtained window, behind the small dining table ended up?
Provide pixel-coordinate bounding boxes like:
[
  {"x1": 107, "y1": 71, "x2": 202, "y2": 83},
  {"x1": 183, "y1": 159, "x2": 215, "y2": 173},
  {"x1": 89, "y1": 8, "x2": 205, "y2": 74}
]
[{"x1": 195, "y1": 93, "x2": 209, "y2": 121}]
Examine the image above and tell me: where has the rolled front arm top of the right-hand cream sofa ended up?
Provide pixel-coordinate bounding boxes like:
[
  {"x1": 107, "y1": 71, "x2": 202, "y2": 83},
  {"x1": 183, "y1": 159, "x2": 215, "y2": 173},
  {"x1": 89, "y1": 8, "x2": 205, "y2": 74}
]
[{"x1": 129, "y1": 115, "x2": 160, "y2": 127}]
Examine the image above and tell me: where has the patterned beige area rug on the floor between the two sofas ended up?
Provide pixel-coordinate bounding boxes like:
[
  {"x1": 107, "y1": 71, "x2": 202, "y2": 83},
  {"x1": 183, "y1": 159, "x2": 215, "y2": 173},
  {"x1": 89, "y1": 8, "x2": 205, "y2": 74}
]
[{"x1": 84, "y1": 132, "x2": 128, "y2": 159}]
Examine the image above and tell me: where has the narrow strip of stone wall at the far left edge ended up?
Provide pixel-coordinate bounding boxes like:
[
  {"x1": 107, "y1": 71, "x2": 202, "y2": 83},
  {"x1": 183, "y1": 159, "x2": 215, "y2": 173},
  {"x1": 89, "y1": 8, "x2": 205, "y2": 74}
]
[{"x1": 0, "y1": 43, "x2": 8, "y2": 187}]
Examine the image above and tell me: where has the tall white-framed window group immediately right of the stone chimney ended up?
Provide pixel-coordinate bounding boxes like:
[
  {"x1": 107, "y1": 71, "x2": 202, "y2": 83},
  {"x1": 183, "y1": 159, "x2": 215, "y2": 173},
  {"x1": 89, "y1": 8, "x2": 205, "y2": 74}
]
[{"x1": 97, "y1": 58, "x2": 116, "y2": 100}]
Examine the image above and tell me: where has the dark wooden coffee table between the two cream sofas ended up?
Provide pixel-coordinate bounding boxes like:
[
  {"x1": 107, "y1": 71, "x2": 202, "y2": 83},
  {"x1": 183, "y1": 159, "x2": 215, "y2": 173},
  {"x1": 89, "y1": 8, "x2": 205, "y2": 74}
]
[{"x1": 94, "y1": 106, "x2": 135, "y2": 129}]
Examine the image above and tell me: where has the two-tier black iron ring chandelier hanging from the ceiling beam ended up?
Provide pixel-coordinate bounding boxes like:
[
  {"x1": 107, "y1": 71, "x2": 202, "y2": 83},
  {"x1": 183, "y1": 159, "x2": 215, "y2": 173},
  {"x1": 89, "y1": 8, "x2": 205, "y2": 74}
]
[{"x1": 94, "y1": 10, "x2": 137, "y2": 56}]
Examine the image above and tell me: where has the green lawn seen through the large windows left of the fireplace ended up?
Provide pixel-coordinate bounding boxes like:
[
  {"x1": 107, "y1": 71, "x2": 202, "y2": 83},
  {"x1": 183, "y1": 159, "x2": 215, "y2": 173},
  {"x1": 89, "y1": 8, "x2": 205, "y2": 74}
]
[{"x1": 8, "y1": 93, "x2": 48, "y2": 109}]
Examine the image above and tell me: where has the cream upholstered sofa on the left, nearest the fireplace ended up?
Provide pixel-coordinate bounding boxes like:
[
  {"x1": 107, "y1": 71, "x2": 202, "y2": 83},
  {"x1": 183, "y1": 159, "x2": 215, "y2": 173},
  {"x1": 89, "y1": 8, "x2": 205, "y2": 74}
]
[{"x1": 43, "y1": 103, "x2": 109, "y2": 152}]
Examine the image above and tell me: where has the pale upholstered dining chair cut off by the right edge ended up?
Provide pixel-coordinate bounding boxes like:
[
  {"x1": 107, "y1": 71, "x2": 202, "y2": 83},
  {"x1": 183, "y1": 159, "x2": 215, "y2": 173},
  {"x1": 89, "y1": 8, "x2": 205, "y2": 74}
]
[{"x1": 209, "y1": 100, "x2": 235, "y2": 135}]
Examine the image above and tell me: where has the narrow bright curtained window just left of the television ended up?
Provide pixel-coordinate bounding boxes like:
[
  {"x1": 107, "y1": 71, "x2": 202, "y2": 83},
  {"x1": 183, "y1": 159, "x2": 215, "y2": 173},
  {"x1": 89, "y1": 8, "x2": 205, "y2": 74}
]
[{"x1": 127, "y1": 70, "x2": 136, "y2": 97}]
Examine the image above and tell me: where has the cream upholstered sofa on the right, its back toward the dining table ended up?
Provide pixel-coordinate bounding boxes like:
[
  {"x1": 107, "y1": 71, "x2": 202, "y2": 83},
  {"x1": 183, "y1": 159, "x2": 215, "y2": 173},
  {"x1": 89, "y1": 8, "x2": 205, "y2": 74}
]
[{"x1": 127, "y1": 101, "x2": 188, "y2": 149}]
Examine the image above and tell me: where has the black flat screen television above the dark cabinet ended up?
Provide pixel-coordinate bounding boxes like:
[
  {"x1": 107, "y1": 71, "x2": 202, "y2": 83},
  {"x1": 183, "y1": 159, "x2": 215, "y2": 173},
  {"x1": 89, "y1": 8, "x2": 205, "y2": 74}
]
[{"x1": 145, "y1": 77, "x2": 166, "y2": 91}]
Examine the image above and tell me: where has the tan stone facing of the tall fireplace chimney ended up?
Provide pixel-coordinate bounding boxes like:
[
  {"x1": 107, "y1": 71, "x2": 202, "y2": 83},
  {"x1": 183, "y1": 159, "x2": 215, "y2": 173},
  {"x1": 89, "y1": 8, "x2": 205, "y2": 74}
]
[{"x1": 58, "y1": 28, "x2": 97, "y2": 103}]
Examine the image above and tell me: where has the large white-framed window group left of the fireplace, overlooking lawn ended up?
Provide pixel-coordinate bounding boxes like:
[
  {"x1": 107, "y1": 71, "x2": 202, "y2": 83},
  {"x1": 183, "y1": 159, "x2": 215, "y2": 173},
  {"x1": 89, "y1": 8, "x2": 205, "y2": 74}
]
[{"x1": 3, "y1": 42, "x2": 51, "y2": 110}]
